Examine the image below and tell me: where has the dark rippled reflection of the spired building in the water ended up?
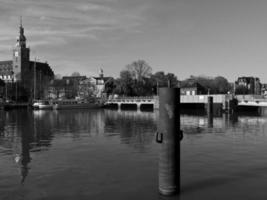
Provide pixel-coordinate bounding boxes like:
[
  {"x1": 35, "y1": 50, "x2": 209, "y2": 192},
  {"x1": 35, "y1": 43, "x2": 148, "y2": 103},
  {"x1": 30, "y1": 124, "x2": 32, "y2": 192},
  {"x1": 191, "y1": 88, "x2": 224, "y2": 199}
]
[{"x1": 0, "y1": 110, "x2": 52, "y2": 184}]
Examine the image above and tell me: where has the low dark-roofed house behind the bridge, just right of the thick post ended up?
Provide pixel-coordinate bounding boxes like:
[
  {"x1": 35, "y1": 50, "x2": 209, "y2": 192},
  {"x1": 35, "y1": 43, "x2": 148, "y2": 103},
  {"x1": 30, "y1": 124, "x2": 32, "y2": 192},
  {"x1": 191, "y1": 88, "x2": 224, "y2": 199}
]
[{"x1": 180, "y1": 81, "x2": 206, "y2": 95}]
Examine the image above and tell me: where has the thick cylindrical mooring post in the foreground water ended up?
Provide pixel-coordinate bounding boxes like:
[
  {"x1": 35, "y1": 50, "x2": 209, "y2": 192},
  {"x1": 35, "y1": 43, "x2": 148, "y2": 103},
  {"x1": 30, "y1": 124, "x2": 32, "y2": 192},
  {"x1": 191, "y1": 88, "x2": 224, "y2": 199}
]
[{"x1": 156, "y1": 88, "x2": 183, "y2": 195}]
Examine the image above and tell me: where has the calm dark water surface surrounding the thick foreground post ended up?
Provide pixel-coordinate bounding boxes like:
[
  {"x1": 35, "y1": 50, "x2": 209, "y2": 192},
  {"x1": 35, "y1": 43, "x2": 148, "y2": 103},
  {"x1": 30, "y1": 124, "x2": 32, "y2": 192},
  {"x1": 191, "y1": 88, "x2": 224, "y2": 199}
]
[{"x1": 0, "y1": 110, "x2": 267, "y2": 200}]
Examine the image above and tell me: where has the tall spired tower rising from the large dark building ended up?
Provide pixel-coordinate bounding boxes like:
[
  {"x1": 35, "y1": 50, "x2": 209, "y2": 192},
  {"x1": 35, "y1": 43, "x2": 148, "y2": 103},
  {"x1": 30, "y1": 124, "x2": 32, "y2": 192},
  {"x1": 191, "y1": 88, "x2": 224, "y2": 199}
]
[{"x1": 13, "y1": 18, "x2": 30, "y2": 81}]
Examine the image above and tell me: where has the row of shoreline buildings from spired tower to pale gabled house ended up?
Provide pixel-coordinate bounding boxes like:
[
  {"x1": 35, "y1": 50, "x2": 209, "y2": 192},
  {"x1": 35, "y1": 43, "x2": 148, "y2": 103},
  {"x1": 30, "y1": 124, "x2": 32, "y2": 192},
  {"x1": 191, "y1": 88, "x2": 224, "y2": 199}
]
[{"x1": 0, "y1": 21, "x2": 110, "y2": 101}]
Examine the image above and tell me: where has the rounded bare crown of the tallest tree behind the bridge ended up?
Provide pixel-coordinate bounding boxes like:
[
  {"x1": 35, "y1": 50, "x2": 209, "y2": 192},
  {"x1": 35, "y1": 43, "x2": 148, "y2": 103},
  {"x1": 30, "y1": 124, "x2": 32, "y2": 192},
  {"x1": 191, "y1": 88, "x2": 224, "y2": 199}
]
[{"x1": 126, "y1": 60, "x2": 152, "y2": 81}]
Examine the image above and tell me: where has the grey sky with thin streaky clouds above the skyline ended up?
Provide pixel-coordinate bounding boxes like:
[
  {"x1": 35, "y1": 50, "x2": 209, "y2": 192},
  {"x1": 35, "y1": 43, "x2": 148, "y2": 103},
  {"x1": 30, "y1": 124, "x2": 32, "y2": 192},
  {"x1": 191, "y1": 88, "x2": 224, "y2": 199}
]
[{"x1": 0, "y1": 0, "x2": 267, "y2": 82}]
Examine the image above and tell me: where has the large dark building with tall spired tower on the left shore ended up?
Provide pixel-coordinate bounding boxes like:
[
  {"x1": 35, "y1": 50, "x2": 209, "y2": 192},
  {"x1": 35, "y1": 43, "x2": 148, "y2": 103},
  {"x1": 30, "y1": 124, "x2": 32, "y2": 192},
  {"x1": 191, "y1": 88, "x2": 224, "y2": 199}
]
[{"x1": 0, "y1": 22, "x2": 54, "y2": 100}]
